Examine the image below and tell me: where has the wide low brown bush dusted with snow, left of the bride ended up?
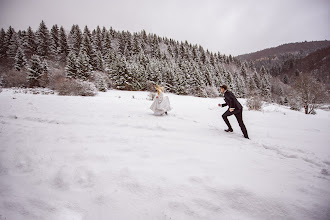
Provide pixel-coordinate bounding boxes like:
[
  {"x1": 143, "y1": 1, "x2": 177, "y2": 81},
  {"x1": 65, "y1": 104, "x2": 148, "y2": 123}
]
[{"x1": 56, "y1": 79, "x2": 97, "y2": 96}]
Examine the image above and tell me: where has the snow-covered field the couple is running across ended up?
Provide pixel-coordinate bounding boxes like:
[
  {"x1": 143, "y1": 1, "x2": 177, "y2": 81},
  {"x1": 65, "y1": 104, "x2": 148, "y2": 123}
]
[{"x1": 0, "y1": 89, "x2": 330, "y2": 220}]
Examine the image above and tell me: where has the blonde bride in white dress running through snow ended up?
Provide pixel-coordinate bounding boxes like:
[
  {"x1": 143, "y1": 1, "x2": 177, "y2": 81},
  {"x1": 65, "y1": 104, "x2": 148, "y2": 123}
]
[{"x1": 150, "y1": 84, "x2": 171, "y2": 115}]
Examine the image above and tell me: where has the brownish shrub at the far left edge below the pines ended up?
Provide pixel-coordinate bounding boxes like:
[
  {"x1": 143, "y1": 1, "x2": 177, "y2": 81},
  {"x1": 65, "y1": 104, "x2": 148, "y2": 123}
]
[{"x1": 2, "y1": 70, "x2": 28, "y2": 88}]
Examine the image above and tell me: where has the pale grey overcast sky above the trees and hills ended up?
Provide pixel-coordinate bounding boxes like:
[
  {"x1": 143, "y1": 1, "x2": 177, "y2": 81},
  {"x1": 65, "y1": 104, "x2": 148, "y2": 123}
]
[{"x1": 0, "y1": 0, "x2": 330, "y2": 55}]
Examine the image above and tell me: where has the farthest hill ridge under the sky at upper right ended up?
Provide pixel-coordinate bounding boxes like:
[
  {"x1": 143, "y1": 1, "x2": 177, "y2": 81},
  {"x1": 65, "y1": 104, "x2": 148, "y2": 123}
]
[{"x1": 237, "y1": 41, "x2": 330, "y2": 61}]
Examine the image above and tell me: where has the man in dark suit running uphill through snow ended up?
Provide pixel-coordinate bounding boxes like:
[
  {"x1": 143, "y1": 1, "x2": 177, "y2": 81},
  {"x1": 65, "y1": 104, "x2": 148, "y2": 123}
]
[{"x1": 219, "y1": 85, "x2": 249, "y2": 139}]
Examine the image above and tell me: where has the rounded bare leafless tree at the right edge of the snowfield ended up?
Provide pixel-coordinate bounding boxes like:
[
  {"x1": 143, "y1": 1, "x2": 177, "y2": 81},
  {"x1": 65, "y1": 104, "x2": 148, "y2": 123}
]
[{"x1": 294, "y1": 73, "x2": 327, "y2": 114}]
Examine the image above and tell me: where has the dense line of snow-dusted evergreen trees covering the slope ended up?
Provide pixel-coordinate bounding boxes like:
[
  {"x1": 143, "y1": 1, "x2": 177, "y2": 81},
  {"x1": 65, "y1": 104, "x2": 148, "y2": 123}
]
[{"x1": 0, "y1": 21, "x2": 271, "y2": 99}]
